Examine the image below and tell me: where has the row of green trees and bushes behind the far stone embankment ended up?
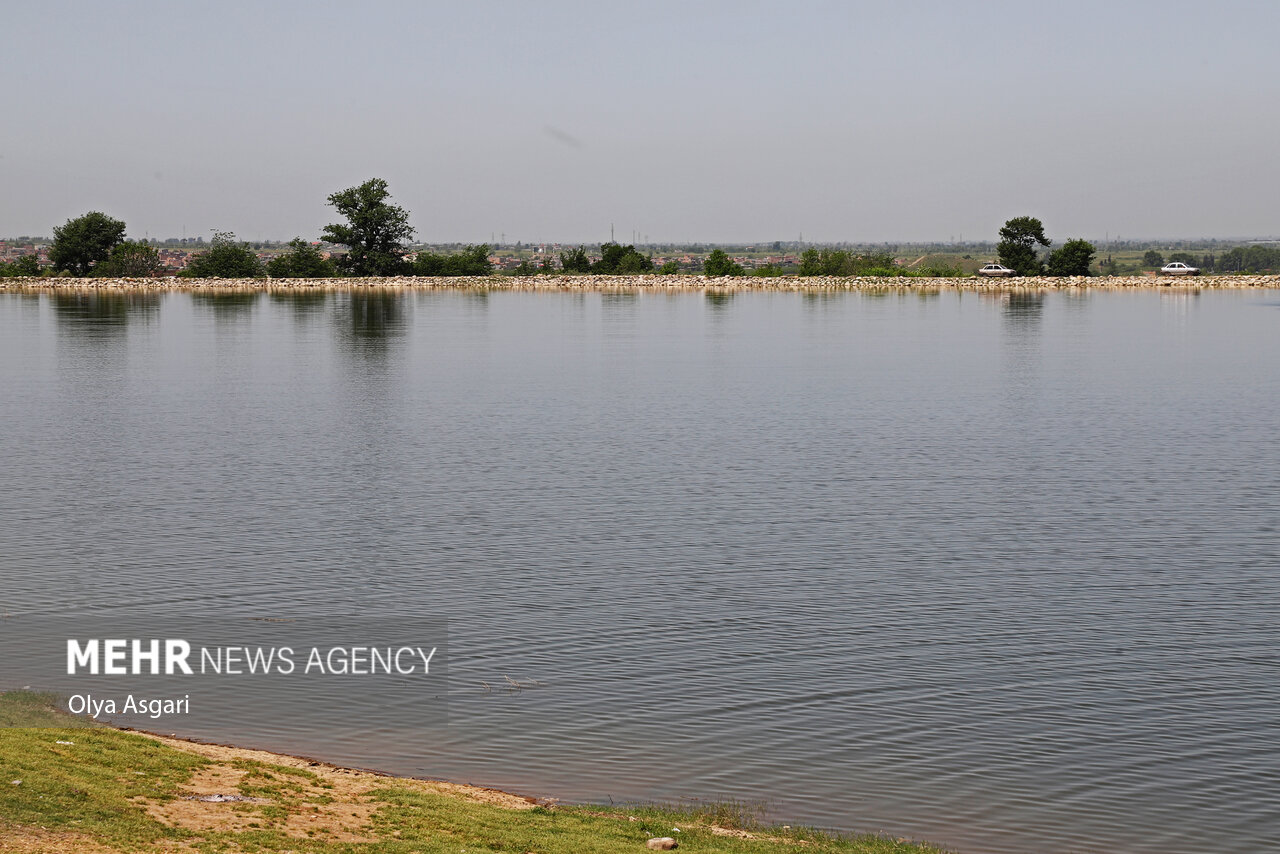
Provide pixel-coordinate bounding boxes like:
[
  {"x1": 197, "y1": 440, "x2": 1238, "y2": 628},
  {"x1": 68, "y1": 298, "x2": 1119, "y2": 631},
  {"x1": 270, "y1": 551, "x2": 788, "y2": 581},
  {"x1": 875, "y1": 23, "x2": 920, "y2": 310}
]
[{"x1": 0, "y1": 178, "x2": 1280, "y2": 279}]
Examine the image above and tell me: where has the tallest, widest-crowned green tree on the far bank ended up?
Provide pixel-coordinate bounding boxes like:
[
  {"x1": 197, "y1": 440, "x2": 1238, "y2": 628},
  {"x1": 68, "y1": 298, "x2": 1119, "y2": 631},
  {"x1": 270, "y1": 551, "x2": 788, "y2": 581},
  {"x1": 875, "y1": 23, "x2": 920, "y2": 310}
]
[{"x1": 321, "y1": 178, "x2": 413, "y2": 275}]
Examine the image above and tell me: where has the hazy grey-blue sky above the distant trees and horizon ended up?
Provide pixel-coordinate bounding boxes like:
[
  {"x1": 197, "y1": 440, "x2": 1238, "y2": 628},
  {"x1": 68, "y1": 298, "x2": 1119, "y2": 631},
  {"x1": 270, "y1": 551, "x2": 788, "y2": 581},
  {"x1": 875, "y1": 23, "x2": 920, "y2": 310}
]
[{"x1": 0, "y1": 0, "x2": 1280, "y2": 242}]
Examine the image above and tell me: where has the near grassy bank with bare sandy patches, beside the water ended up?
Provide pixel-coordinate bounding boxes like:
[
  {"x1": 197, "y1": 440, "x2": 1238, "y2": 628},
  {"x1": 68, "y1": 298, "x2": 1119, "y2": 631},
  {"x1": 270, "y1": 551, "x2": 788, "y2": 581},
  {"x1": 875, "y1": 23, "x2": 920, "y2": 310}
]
[{"x1": 0, "y1": 691, "x2": 940, "y2": 854}]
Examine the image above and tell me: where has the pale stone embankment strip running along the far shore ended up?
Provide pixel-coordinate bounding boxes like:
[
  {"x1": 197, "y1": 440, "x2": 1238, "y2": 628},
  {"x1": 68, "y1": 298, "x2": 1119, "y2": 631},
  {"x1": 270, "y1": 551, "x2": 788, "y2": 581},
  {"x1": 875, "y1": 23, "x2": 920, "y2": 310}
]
[{"x1": 0, "y1": 274, "x2": 1280, "y2": 293}]
